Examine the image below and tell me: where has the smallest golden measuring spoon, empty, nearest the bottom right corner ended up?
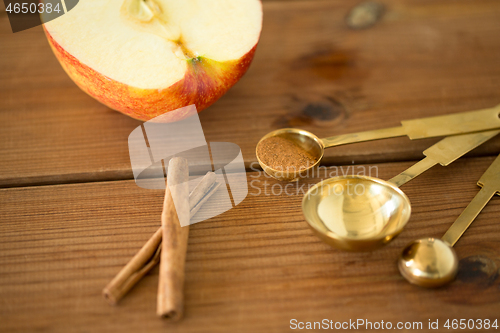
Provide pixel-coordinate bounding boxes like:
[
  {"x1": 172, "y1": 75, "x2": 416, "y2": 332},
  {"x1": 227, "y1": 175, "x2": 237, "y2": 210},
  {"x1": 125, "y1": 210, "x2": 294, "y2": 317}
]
[{"x1": 398, "y1": 156, "x2": 500, "y2": 287}]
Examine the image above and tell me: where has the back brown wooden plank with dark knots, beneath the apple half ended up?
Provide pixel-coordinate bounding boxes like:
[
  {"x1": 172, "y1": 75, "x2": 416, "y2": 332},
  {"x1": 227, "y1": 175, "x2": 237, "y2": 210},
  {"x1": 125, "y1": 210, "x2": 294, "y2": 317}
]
[{"x1": 0, "y1": 0, "x2": 500, "y2": 187}]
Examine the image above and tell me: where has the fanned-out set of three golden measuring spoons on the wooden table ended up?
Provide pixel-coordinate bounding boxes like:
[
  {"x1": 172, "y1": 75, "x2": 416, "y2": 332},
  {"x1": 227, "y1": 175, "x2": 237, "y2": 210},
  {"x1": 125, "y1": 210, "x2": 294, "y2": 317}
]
[{"x1": 257, "y1": 105, "x2": 500, "y2": 287}]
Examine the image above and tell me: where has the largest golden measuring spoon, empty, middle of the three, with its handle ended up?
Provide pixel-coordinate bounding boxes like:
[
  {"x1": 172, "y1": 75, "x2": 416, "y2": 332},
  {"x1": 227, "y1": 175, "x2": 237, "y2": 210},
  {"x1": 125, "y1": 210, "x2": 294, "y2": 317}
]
[{"x1": 302, "y1": 130, "x2": 500, "y2": 251}]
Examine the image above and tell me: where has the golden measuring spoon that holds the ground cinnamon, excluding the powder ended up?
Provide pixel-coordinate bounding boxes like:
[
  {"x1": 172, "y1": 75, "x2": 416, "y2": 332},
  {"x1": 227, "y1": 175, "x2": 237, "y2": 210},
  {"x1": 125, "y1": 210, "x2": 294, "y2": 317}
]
[{"x1": 256, "y1": 105, "x2": 500, "y2": 181}]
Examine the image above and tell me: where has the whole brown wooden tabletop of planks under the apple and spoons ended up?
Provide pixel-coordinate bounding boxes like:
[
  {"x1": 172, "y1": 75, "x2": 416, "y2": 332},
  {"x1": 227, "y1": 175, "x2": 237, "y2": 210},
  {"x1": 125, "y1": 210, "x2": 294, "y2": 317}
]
[{"x1": 0, "y1": 0, "x2": 500, "y2": 332}]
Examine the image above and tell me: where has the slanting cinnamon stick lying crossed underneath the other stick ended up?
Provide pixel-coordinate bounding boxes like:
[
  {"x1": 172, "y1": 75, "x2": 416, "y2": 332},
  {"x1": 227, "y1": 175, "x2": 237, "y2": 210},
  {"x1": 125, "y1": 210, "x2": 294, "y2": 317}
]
[{"x1": 103, "y1": 172, "x2": 220, "y2": 305}]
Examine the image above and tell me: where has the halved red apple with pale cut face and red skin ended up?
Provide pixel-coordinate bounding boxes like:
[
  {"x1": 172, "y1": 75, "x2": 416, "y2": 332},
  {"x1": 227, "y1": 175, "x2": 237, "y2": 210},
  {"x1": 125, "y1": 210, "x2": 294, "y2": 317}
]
[{"x1": 44, "y1": 0, "x2": 262, "y2": 121}]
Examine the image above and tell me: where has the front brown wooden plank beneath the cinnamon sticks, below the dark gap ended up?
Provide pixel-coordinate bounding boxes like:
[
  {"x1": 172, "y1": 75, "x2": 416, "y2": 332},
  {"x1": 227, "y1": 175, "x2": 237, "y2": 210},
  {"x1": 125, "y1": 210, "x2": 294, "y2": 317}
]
[{"x1": 0, "y1": 157, "x2": 500, "y2": 333}]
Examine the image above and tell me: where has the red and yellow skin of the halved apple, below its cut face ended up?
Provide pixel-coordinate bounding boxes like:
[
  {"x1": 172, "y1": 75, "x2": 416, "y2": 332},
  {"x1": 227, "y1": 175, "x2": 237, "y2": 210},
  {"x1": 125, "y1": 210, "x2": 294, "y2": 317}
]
[{"x1": 44, "y1": 27, "x2": 257, "y2": 122}]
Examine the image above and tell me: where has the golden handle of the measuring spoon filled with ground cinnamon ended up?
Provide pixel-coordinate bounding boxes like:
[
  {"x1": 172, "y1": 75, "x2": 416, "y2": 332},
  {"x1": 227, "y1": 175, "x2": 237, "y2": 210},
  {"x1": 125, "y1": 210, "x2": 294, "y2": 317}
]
[{"x1": 321, "y1": 105, "x2": 500, "y2": 148}]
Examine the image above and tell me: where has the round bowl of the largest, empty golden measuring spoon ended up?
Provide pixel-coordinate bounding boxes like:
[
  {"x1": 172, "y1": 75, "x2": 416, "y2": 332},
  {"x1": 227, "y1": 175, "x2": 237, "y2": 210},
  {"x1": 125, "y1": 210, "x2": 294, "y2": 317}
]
[{"x1": 302, "y1": 176, "x2": 411, "y2": 251}]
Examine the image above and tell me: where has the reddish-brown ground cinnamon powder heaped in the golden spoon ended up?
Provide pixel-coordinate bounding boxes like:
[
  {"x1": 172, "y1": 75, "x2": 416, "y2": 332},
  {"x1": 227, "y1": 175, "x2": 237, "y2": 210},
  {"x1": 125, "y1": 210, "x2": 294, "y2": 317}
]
[{"x1": 257, "y1": 136, "x2": 316, "y2": 172}]
